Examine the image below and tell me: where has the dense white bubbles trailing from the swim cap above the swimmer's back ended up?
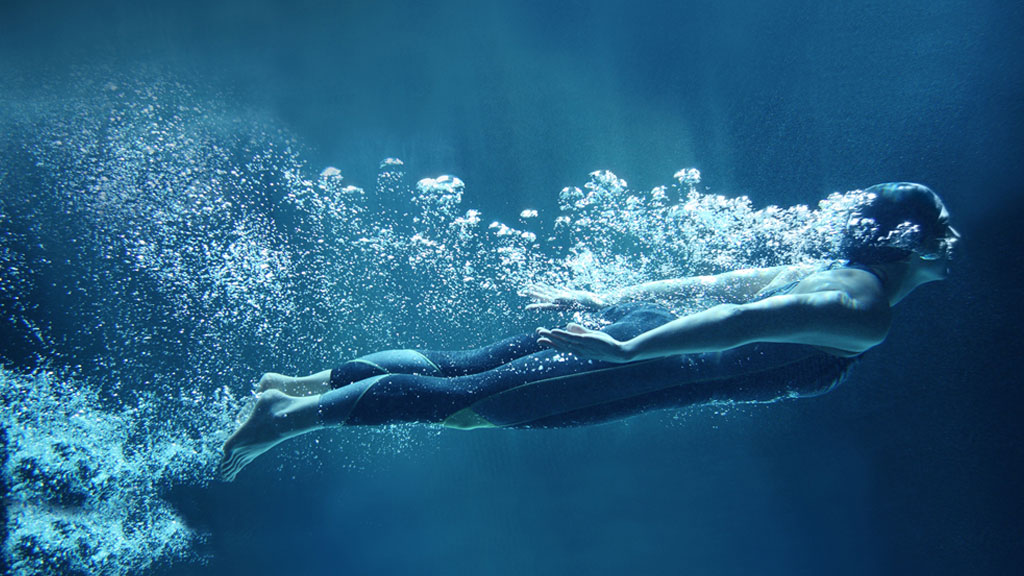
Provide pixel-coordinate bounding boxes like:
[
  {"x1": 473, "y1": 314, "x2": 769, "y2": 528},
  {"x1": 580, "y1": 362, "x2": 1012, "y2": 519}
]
[{"x1": 499, "y1": 168, "x2": 864, "y2": 314}]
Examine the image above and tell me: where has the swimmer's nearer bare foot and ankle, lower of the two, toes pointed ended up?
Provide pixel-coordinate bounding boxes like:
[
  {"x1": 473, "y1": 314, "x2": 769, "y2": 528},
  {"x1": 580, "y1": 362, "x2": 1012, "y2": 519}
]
[{"x1": 220, "y1": 389, "x2": 319, "y2": 482}]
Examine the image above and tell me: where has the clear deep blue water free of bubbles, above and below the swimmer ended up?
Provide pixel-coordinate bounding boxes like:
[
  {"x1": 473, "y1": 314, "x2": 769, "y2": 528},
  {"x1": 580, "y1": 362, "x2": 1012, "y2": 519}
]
[{"x1": 0, "y1": 0, "x2": 1024, "y2": 574}]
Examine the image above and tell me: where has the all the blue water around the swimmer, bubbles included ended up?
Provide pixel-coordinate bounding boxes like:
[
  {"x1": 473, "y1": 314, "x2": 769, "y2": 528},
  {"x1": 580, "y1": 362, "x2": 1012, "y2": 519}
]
[{"x1": 0, "y1": 0, "x2": 1024, "y2": 575}]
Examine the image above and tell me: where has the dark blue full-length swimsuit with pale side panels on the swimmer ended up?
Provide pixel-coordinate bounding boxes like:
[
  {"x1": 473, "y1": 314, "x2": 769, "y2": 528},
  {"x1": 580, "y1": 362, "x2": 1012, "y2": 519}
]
[{"x1": 321, "y1": 304, "x2": 851, "y2": 428}]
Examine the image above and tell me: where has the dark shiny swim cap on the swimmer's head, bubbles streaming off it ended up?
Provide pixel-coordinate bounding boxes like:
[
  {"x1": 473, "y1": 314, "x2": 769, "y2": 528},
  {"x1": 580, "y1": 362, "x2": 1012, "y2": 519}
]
[{"x1": 842, "y1": 182, "x2": 948, "y2": 264}]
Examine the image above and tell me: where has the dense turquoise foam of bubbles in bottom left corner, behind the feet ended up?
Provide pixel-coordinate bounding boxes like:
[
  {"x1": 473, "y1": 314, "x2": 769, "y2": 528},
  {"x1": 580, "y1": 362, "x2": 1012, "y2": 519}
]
[{"x1": 0, "y1": 368, "x2": 236, "y2": 575}]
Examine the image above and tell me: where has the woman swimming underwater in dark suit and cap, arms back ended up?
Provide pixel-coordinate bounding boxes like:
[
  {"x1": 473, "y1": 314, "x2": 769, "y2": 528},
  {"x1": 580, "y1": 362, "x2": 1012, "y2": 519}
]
[{"x1": 220, "y1": 182, "x2": 959, "y2": 481}]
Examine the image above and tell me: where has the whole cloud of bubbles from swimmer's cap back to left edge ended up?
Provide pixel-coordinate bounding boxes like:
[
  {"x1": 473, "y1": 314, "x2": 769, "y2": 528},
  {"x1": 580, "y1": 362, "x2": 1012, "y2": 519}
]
[{"x1": 0, "y1": 77, "x2": 872, "y2": 574}]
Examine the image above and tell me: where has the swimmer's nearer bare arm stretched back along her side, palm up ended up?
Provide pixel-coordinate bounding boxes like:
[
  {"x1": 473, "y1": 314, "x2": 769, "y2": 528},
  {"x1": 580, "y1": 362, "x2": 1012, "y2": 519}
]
[{"x1": 539, "y1": 290, "x2": 891, "y2": 362}]
